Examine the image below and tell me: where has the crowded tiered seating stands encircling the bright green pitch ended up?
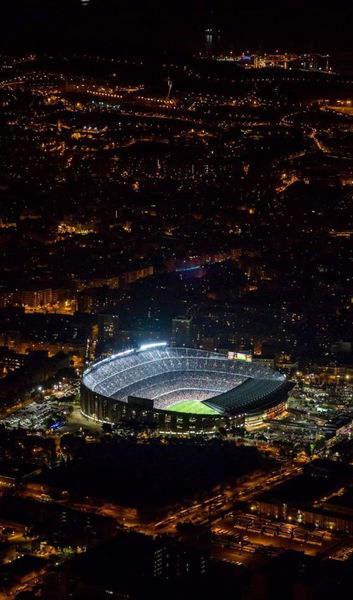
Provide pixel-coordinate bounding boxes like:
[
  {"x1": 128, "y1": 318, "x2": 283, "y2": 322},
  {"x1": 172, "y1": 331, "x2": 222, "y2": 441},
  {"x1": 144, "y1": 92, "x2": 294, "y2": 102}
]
[{"x1": 83, "y1": 346, "x2": 292, "y2": 424}]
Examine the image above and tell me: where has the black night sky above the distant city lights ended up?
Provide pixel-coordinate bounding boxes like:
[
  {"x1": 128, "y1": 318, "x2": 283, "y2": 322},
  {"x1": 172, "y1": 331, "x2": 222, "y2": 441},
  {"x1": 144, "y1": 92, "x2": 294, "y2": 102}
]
[{"x1": 0, "y1": 0, "x2": 353, "y2": 53}]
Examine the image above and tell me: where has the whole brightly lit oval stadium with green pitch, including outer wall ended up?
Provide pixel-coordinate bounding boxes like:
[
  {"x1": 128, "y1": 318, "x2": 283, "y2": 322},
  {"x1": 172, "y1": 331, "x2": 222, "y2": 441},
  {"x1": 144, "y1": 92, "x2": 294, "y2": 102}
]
[{"x1": 81, "y1": 343, "x2": 292, "y2": 432}]
